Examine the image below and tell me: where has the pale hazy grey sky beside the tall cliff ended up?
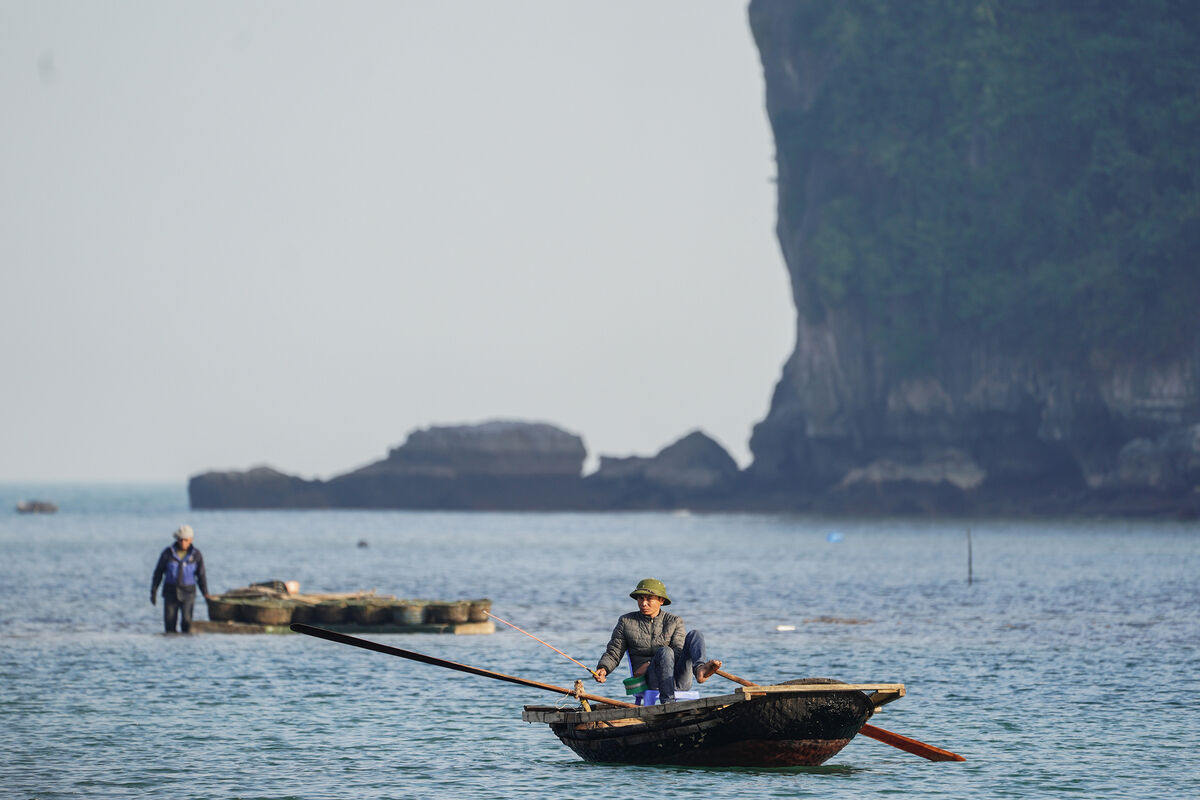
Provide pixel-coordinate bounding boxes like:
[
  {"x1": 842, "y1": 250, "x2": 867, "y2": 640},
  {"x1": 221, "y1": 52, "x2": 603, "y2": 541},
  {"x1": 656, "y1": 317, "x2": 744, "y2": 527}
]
[{"x1": 0, "y1": 0, "x2": 794, "y2": 481}]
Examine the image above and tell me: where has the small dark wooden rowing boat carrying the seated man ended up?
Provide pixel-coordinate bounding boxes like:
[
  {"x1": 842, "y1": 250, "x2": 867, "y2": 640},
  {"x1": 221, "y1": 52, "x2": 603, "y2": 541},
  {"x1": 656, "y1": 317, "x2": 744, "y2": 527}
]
[{"x1": 521, "y1": 679, "x2": 905, "y2": 766}]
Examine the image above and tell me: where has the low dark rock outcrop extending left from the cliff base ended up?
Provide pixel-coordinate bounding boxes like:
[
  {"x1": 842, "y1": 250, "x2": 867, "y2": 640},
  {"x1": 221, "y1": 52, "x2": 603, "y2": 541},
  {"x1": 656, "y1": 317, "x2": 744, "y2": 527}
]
[{"x1": 188, "y1": 421, "x2": 739, "y2": 511}]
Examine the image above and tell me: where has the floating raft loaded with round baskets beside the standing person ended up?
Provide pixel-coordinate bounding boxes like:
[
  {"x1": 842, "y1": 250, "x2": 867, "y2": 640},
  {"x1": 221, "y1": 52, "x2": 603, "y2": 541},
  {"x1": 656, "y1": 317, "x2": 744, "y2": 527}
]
[{"x1": 192, "y1": 581, "x2": 496, "y2": 633}]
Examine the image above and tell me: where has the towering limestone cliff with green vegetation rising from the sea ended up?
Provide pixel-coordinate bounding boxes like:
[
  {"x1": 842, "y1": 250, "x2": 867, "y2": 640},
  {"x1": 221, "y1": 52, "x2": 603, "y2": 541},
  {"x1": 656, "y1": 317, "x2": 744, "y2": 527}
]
[{"x1": 749, "y1": 0, "x2": 1200, "y2": 507}]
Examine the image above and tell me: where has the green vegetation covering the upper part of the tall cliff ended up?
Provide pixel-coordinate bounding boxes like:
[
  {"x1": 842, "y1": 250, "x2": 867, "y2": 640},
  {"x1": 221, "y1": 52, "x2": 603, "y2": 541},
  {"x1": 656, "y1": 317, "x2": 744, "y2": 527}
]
[{"x1": 768, "y1": 0, "x2": 1200, "y2": 367}]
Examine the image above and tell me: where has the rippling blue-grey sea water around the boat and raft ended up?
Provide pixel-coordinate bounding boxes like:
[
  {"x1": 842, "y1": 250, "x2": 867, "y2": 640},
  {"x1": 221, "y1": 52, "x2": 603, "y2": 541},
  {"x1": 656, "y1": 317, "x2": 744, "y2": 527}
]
[{"x1": 0, "y1": 486, "x2": 1200, "y2": 799}]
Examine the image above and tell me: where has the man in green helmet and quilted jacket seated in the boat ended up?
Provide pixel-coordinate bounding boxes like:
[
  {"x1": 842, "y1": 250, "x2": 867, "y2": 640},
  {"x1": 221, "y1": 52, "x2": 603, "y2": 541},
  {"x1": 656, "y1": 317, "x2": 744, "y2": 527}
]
[{"x1": 593, "y1": 578, "x2": 721, "y2": 703}]
